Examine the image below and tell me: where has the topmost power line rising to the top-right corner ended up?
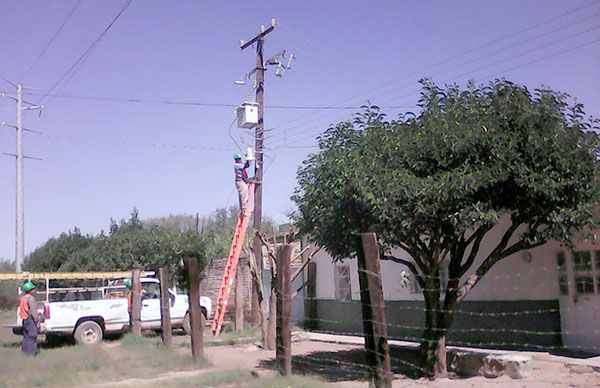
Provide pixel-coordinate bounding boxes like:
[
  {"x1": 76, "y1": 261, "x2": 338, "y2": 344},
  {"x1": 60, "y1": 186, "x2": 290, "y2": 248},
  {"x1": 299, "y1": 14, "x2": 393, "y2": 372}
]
[{"x1": 264, "y1": 0, "x2": 600, "y2": 141}]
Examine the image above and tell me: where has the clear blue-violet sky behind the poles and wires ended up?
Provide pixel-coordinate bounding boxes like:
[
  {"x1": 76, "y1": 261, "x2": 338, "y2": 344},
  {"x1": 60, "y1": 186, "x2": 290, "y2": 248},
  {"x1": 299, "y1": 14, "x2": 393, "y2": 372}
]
[{"x1": 0, "y1": 0, "x2": 600, "y2": 260}]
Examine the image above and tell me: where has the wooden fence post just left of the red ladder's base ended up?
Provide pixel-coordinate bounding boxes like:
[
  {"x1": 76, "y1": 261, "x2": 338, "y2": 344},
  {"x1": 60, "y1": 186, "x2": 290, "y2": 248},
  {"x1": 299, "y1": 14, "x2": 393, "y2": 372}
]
[{"x1": 185, "y1": 257, "x2": 204, "y2": 361}]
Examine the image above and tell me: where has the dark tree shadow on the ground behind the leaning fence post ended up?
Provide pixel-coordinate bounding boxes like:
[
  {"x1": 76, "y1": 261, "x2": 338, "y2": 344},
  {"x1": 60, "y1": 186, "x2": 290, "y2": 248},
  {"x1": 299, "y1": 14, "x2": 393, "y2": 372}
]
[{"x1": 259, "y1": 347, "x2": 421, "y2": 382}]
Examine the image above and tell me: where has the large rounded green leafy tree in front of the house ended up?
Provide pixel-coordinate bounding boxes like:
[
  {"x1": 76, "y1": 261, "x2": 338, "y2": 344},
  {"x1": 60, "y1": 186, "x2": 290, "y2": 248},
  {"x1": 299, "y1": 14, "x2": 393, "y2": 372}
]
[{"x1": 293, "y1": 80, "x2": 599, "y2": 376}]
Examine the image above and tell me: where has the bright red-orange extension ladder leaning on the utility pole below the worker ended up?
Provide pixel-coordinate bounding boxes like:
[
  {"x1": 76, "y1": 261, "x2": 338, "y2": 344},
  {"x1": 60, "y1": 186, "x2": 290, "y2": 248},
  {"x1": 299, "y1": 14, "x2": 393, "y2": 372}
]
[{"x1": 210, "y1": 182, "x2": 254, "y2": 335}]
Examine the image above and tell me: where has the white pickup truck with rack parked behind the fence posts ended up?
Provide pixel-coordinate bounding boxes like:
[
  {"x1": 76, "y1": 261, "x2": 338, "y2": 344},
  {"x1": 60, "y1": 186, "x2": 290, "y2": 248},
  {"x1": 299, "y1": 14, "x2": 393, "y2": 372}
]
[{"x1": 13, "y1": 277, "x2": 212, "y2": 345}]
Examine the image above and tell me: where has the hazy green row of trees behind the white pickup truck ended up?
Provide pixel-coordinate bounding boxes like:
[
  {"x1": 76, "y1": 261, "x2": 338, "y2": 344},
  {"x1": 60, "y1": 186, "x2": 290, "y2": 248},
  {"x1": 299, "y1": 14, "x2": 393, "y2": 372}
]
[{"x1": 24, "y1": 207, "x2": 273, "y2": 271}]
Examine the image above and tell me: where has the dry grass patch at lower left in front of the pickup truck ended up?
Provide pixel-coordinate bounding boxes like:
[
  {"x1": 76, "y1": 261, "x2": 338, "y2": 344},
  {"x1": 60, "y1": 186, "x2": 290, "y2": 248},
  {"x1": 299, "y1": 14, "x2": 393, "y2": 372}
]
[{"x1": 0, "y1": 336, "x2": 208, "y2": 388}]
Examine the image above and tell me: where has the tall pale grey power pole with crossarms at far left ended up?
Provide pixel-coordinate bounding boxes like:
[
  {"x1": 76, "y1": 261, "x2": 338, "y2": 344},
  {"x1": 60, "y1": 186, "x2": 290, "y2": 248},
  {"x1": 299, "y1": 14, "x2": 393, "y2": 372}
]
[{"x1": 1, "y1": 81, "x2": 44, "y2": 272}]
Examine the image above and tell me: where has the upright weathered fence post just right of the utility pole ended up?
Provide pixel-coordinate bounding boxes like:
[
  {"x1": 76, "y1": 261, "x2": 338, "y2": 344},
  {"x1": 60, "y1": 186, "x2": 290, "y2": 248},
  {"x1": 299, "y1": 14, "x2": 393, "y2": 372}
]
[{"x1": 275, "y1": 244, "x2": 292, "y2": 376}]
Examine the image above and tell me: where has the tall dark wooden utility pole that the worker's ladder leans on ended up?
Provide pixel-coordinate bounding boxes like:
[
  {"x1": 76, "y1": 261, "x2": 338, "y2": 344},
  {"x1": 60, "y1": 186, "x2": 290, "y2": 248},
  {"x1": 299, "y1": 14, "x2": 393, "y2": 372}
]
[{"x1": 240, "y1": 19, "x2": 275, "y2": 324}]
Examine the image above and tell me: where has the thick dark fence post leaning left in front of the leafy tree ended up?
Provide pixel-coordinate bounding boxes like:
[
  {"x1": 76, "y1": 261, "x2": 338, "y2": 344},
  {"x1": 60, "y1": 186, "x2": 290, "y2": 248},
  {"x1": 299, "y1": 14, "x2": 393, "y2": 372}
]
[{"x1": 357, "y1": 233, "x2": 392, "y2": 388}]
